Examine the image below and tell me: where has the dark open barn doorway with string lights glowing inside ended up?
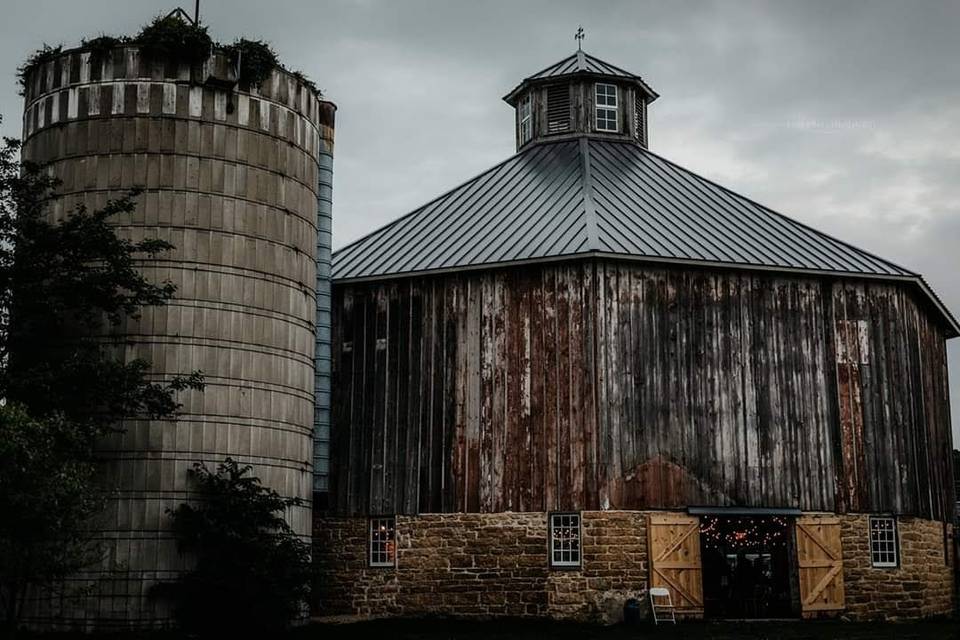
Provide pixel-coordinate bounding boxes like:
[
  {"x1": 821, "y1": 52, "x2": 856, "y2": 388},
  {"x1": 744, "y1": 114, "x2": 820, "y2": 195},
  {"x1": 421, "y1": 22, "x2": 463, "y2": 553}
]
[{"x1": 700, "y1": 515, "x2": 799, "y2": 619}]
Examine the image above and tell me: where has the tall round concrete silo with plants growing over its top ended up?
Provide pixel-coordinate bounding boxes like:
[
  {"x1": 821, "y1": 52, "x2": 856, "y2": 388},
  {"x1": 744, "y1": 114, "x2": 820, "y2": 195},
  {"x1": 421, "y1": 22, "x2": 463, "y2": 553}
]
[{"x1": 23, "y1": 36, "x2": 336, "y2": 628}]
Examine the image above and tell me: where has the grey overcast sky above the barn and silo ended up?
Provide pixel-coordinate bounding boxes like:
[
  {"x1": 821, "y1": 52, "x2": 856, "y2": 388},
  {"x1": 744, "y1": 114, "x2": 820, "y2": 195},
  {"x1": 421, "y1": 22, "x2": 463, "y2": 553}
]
[{"x1": 0, "y1": 0, "x2": 960, "y2": 441}]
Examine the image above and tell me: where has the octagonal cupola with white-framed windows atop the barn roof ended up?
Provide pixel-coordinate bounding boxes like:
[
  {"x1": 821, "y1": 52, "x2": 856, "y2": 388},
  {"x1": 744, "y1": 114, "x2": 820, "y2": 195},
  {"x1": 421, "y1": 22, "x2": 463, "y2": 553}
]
[{"x1": 503, "y1": 49, "x2": 659, "y2": 151}]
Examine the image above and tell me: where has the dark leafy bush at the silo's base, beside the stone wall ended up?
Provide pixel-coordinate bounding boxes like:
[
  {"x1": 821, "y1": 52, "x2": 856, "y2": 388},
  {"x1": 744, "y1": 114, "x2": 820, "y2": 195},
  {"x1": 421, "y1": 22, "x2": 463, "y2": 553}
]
[{"x1": 157, "y1": 458, "x2": 313, "y2": 637}]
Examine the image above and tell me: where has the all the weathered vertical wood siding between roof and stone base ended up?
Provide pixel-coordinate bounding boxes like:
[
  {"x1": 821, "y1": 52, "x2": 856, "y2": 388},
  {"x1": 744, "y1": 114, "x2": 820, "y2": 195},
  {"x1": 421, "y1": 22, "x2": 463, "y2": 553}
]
[{"x1": 332, "y1": 261, "x2": 953, "y2": 518}]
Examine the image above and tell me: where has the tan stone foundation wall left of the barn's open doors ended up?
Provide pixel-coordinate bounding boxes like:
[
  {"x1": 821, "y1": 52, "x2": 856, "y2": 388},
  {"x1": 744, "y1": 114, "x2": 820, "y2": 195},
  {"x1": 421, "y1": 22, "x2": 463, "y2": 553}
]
[{"x1": 314, "y1": 511, "x2": 649, "y2": 622}]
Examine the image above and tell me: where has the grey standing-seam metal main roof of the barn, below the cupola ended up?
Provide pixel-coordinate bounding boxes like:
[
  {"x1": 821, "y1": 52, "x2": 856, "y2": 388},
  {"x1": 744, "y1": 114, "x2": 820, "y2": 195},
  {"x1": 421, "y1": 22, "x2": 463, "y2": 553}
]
[{"x1": 333, "y1": 137, "x2": 960, "y2": 332}]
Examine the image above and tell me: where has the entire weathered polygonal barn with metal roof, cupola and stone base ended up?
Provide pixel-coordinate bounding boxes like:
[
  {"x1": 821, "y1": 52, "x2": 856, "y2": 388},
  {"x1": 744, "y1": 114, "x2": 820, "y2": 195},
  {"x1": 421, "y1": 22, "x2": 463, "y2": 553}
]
[{"x1": 314, "y1": 51, "x2": 960, "y2": 619}]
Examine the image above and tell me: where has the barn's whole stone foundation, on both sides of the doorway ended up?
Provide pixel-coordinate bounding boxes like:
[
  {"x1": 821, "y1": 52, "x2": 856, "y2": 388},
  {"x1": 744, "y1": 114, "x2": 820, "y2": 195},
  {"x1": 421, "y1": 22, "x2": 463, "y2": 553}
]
[{"x1": 314, "y1": 511, "x2": 953, "y2": 623}]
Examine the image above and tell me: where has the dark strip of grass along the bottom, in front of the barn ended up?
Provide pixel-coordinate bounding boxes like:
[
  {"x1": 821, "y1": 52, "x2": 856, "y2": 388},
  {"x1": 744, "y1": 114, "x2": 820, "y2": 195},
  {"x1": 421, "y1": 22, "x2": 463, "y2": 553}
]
[{"x1": 13, "y1": 620, "x2": 960, "y2": 640}]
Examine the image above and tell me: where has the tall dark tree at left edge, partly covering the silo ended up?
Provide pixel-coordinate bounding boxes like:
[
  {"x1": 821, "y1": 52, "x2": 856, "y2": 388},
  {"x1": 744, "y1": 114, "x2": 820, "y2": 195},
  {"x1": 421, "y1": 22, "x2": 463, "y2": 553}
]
[{"x1": 0, "y1": 131, "x2": 203, "y2": 625}]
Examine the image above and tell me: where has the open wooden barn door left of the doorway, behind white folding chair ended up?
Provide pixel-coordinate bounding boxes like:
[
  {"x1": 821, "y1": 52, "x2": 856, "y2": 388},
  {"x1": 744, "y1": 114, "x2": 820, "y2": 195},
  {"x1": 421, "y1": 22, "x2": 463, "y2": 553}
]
[{"x1": 647, "y1": 513, "x2": 703, "y2": 615}]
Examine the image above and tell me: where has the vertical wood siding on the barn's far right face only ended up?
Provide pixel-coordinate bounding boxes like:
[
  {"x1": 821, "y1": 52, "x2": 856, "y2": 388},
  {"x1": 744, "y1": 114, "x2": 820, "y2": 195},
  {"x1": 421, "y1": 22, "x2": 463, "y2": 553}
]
[{"x1": 832, "y1": 283, "x2": 954, "y2": 520}]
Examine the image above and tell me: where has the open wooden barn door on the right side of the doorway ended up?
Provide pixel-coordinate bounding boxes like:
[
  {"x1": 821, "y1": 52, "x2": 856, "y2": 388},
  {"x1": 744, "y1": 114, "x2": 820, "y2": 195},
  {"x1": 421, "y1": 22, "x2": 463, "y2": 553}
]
[{"x1": 797, "y1": 516, "x2": 844, "y2": 617}]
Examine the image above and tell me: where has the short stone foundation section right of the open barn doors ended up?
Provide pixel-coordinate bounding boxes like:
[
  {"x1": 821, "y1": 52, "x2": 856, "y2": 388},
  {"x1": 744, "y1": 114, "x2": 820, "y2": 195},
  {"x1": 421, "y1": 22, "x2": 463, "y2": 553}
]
[{"x1": 841, "y1": 514, "x2": 954, "y2": 620}]
